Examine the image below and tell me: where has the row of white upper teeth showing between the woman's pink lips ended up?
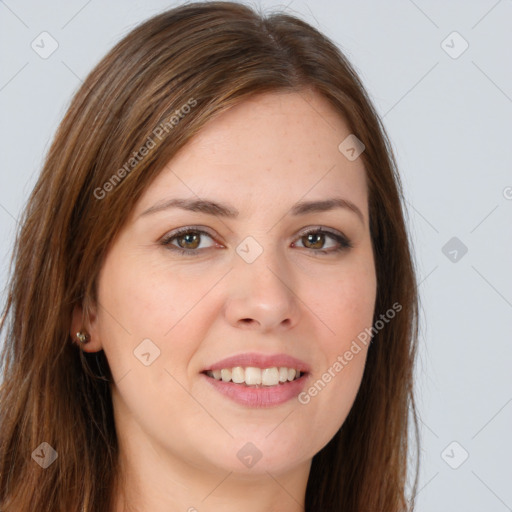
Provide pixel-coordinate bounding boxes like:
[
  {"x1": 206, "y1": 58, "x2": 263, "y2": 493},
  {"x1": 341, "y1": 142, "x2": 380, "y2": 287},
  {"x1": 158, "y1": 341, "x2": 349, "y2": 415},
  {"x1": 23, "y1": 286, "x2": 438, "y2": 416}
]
[{"x1": 206, "y1": 366, "x2": 300, "y2": 386}]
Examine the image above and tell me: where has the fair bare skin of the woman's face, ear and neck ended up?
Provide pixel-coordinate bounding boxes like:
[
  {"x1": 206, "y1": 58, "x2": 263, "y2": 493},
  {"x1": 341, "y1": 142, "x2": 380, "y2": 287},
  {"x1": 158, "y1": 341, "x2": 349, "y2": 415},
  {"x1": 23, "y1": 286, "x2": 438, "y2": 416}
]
[{"x1": 71, "y1": 91, "x2": 376, "y2": 512}]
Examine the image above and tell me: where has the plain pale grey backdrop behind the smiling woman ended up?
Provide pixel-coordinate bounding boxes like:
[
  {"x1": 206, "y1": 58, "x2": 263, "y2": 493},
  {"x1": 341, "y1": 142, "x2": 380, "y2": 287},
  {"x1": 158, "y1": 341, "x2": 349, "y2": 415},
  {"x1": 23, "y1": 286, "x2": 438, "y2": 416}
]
[{"x1": 0, "y1": 0, "x2": 512, "y2": 512}]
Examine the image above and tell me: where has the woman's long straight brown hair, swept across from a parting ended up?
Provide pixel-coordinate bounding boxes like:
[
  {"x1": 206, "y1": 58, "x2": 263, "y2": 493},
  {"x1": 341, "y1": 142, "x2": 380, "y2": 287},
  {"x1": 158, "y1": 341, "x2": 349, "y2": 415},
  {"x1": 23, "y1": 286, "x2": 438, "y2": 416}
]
[{"x1": 0, "y1": 2, "x2": 419, "y2": 512}]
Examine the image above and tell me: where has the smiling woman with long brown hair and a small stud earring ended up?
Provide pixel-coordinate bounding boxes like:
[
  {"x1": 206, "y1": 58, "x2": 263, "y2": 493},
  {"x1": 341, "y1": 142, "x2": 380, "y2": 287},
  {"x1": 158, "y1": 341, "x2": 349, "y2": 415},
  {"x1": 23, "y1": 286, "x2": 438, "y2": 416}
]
[{"x1": 0, "y1": 2, "x2": 418, "y2": 512}]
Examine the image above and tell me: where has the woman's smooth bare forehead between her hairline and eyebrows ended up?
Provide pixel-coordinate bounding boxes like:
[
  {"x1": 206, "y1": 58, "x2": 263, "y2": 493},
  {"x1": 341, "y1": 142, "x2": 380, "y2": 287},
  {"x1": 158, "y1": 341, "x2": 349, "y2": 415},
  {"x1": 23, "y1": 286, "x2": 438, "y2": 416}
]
[{"x1": 130, "y1": 91, "x2": 367, "y2": 218}]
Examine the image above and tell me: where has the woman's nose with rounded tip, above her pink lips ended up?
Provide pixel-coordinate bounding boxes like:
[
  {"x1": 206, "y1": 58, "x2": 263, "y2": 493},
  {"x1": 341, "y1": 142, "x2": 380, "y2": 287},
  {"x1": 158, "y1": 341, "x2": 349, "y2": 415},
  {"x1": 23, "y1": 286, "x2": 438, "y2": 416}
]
[{"x1": 225, "y1": 244, "x2": 299, "y2": 332}]
